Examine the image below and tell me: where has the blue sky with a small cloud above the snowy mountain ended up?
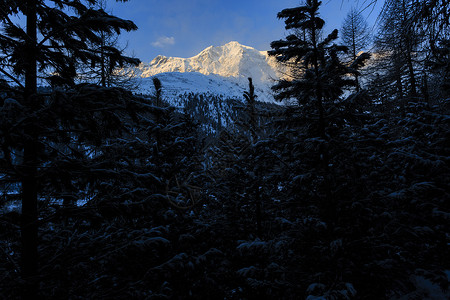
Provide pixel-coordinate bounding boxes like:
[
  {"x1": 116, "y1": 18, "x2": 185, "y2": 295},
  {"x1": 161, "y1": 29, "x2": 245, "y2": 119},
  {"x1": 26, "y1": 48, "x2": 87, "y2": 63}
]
[{"x1": 107, "y1": 0, "x2": 384, "y2": 62}]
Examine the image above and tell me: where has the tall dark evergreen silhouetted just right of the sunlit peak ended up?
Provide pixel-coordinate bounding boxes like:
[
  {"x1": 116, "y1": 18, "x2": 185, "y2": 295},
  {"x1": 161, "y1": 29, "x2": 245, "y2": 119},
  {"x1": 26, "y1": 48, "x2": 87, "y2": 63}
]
[{"x1": 269, "y1": 0, "x2": 367, "y2": 137}]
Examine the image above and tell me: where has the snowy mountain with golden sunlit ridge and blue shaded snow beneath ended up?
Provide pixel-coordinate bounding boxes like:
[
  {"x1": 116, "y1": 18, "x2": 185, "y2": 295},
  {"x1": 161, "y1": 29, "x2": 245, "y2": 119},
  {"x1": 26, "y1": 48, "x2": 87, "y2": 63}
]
[{"x1": 131, "y1": 42, "x2": 282, "y2": 106}]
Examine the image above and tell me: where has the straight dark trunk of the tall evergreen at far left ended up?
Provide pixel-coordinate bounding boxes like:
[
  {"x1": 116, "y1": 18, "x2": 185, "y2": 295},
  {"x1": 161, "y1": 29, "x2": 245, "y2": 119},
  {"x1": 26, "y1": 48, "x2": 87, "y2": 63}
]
[{"x1": 21, "y1": 0, "x2": 39, "y2": 299}]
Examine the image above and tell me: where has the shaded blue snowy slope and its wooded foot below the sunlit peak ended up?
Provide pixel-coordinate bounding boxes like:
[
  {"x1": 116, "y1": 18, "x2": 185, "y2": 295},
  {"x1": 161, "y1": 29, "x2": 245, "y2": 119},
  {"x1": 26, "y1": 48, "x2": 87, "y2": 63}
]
[{"x1": 134, "y1": 72, "x2": 280, "y2": 136}]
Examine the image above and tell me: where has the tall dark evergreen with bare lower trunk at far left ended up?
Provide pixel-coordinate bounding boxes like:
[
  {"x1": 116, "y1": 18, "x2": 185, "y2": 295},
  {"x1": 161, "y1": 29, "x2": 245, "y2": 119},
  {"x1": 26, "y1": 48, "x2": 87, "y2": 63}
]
[{"x1": 0, "y1": 0, "x2": 137, "y2": 299}]
